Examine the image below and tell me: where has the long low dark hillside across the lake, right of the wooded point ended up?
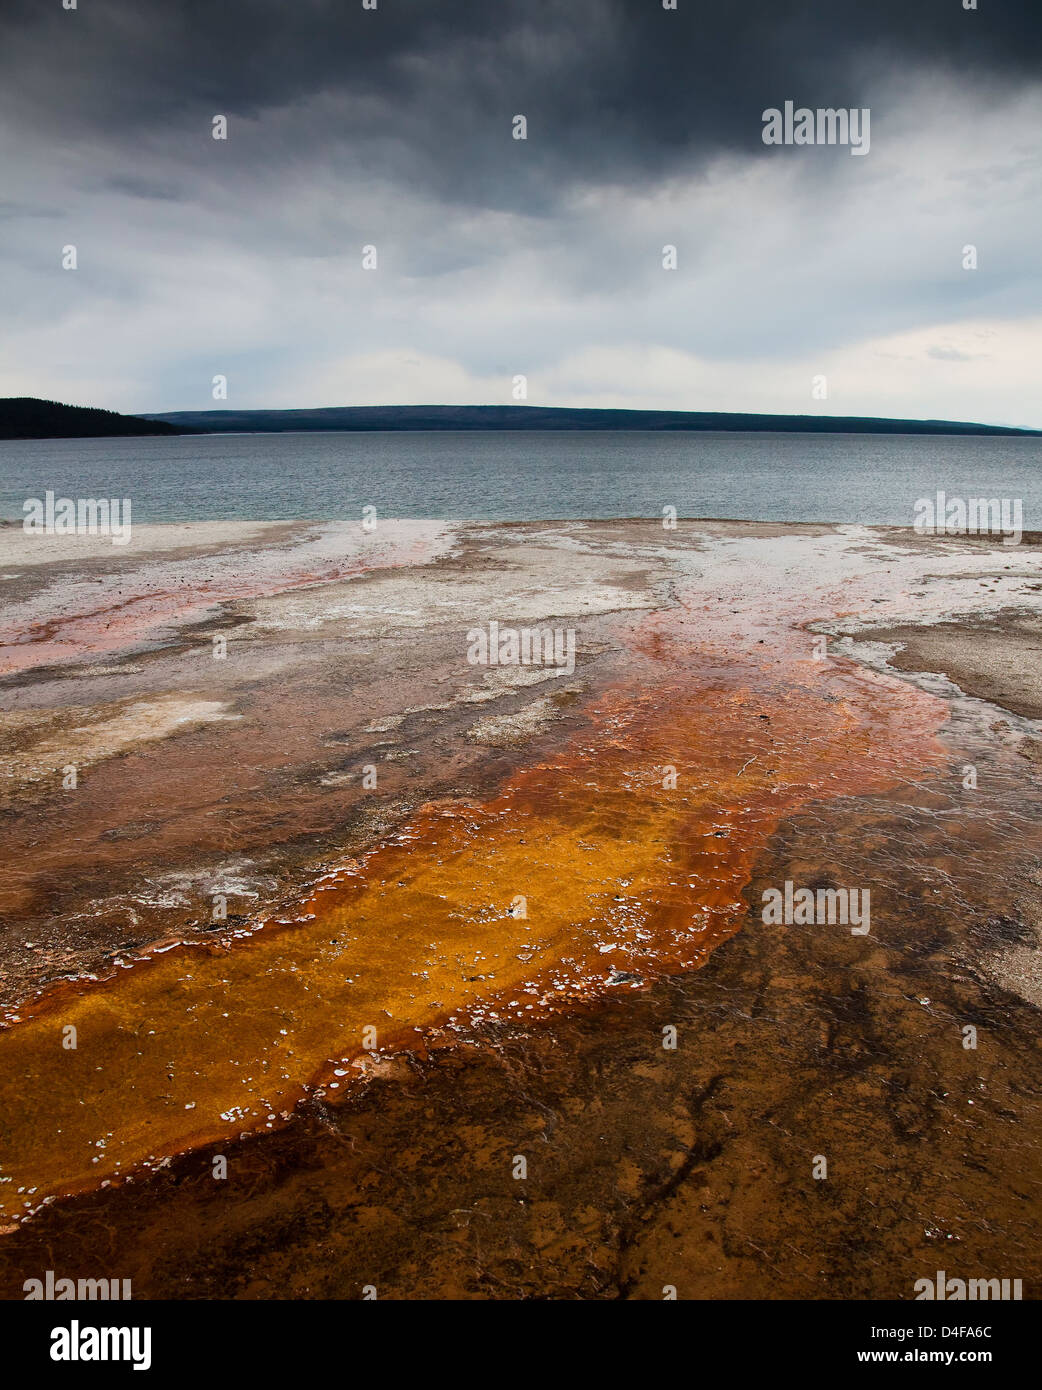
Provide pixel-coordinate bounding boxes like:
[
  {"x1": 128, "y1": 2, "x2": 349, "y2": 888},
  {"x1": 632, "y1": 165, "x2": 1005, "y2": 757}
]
[{"x1": 146, "y1": 406, "x2": 1042, "y2": 435}]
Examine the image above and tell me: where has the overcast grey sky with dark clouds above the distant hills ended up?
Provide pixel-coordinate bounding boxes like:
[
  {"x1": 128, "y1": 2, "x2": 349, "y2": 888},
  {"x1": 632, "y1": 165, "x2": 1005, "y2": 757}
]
[{"x1": 0, "y1": 0, "x2": 1042, "y2": 427}]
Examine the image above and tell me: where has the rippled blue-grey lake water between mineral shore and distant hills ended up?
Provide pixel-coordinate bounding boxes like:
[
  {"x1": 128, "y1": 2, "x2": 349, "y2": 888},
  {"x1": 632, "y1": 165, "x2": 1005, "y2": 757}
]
[{"x1": 0, "y1": 431, "x2": 1042, "y2": 530}]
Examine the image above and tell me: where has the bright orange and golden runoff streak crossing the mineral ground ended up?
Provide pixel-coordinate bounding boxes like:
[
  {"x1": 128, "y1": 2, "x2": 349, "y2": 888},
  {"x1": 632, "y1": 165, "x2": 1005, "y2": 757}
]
[{"x1": 0, "y1": 627, "x2": 945, "y2": 1223}]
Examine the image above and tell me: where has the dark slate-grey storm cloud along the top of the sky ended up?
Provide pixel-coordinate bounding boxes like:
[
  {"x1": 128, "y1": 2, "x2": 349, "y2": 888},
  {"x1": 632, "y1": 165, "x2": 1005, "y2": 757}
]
[{"x1": 0, "y1": 0, "x2": 1042, "y2": 213}]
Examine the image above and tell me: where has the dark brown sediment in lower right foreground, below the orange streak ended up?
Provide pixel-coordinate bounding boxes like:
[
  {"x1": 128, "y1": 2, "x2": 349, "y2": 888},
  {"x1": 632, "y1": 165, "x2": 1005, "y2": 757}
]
[{"x1": 0, "y1": 760, "x2": 1042, "y2": 1300}]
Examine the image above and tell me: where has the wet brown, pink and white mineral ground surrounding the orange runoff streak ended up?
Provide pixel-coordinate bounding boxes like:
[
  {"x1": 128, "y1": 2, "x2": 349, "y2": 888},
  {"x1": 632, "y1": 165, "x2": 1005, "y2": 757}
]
[{"x1": 0, "y1": 523, "x2": 1042, "y2": 1298}]
